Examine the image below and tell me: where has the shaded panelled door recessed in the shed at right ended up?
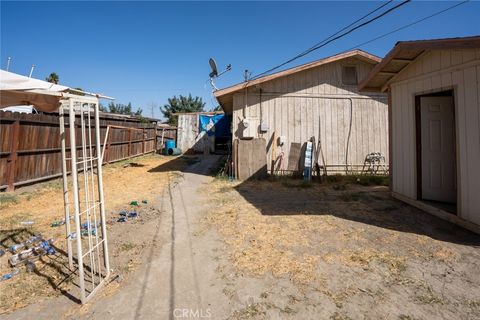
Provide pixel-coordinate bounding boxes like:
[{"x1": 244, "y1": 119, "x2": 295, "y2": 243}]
[{"x1": 420, "y1": 97, "x2": 457, "y2": 203}]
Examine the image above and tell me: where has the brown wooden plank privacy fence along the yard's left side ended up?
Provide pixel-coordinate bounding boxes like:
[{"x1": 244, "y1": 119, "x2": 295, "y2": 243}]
[{"x1": 0, "y1": 111, "x2": 156, "y2": 190}]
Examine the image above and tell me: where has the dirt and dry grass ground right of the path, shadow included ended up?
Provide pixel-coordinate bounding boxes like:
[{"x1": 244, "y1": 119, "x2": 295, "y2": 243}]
[{"x1": 204, "y1": 179, "x2": 480, "y2": 319}]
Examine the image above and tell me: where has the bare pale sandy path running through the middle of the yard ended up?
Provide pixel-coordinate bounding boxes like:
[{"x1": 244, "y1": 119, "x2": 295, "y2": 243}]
[{"x1": 75, "y1": 156, "x2": 229, "y2": 319}]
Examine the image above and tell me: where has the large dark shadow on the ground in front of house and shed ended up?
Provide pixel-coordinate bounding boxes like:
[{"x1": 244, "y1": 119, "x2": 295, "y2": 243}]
[{"x1": 235, "y1": 172, "x2": 480, "y2": 246}]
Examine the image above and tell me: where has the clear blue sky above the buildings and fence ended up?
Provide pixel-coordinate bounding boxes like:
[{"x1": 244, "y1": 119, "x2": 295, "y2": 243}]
[{"x1": 0, "y1": 1, "x2": 480, "y2": 117}]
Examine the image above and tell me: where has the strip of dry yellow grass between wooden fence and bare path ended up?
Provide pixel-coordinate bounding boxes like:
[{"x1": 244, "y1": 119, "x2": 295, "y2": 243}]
[{"x1": 0, "y1": 155, "x2": 191, "y2": 314}]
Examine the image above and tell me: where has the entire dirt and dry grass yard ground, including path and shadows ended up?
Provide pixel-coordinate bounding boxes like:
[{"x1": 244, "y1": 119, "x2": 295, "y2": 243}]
[{"x1": 0, "y1": 156, "x2": 480, "y2": 320}]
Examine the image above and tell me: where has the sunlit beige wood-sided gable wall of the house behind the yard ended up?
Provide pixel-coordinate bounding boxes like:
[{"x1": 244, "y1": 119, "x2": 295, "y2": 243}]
[{"x1": 232, "y1": 58, "x2": 388, "y2": 172}]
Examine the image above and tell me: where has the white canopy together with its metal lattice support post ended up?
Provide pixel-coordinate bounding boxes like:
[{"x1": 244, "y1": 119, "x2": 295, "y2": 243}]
[{"x1": 0, "y1": 70, "x2": 113, "y2": 304}]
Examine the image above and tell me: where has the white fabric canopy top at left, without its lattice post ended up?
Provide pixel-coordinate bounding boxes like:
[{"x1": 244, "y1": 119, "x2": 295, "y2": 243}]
[{"x1": 0, "y1": 70, "x2": 112, "y2": 112}]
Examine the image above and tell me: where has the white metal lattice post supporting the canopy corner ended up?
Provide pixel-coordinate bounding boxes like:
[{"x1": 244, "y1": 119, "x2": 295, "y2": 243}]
[{"x1": 59, "y1": 95, "x2": 110, "y2": 304}]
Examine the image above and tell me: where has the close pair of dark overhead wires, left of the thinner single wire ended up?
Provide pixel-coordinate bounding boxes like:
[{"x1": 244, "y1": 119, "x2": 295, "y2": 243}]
[{"x1": 250, "y1": 0, "x2": 411, "y2": 80}]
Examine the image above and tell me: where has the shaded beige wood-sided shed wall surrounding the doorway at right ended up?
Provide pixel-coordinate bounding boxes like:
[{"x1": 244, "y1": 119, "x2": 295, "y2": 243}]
[{"x1": 390, "y1": 49, "x2": 480, "y2": 224}]
